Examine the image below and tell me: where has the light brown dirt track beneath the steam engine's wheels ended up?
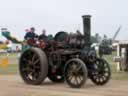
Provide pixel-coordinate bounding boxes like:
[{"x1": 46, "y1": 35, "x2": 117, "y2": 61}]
[{"x1": 0, "y1": 75, "x2": 128, "y2": 96}]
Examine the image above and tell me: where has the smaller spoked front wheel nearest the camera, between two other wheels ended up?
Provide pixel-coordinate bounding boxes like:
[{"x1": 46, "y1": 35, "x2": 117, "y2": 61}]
[{"x1": 64, "y1": 59, "x2": 87, "y2": 88}]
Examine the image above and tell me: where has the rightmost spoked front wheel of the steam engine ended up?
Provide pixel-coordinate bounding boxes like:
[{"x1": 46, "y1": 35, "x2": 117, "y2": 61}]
[{"x1": 90, "y1": 59, "x2": 111, "y2": 85}]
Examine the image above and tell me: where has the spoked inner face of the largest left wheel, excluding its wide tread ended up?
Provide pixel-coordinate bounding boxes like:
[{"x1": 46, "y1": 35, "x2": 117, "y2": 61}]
[{"x1": 20, "y1": 50, "x2": 41, "y2": 81}]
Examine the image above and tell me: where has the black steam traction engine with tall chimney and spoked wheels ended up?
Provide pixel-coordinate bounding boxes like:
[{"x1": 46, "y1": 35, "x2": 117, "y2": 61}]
[{"x1": 19, "y1": 15, "x2": 111, "y2": 88}]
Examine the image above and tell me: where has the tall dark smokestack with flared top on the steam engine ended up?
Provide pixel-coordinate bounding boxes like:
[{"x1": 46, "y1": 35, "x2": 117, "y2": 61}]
[{"x1": 82, "y1": 15, "x2": 91, "y2": 47}]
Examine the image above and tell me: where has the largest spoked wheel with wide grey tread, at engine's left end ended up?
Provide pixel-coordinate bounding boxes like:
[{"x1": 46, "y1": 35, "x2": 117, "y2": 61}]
[{"x1": 19, "y1": 48, "x2": 48, "y2": 85}]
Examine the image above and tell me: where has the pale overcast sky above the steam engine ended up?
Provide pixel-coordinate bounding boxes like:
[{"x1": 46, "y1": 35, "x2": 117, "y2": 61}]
[{"x1": 0, "y1": 0, "x2": 128, "y2": 40}]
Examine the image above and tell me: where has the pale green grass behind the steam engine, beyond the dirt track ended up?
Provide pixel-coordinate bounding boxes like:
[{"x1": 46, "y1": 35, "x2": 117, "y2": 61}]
[{"x1": 0, "y1": 53, "x2": 128, "y2": 80}]
